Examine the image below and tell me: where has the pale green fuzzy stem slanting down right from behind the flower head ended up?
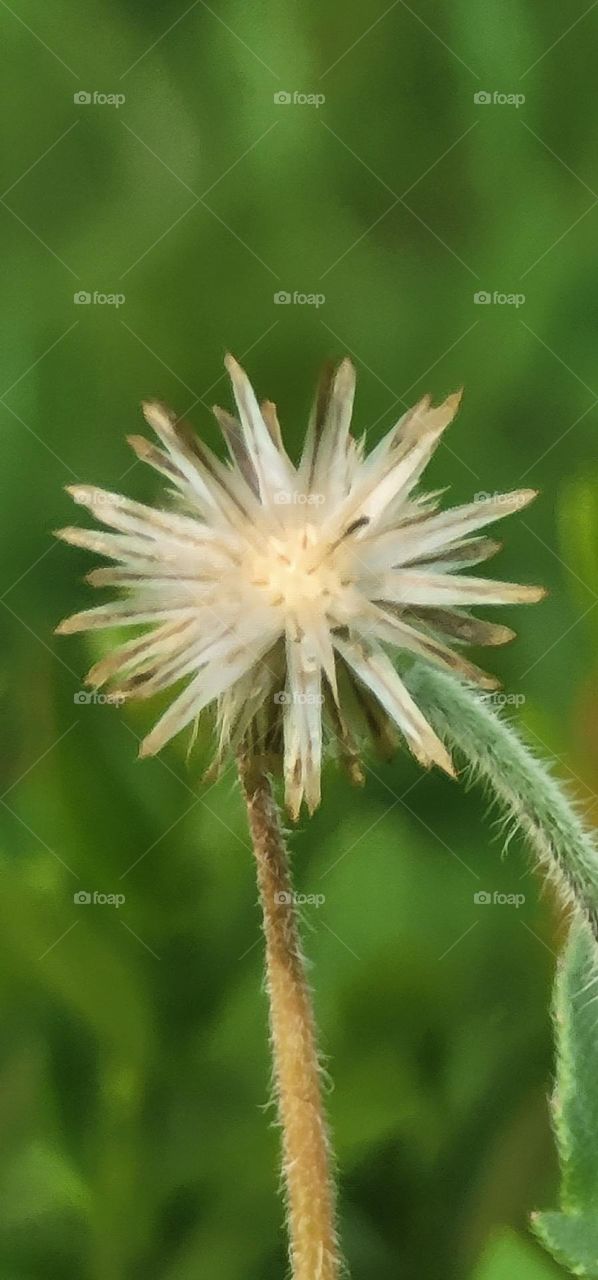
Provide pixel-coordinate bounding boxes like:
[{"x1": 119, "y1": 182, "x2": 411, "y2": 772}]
[{"x1": 406, "y1": 663, "x2": 598, "y2": 940}]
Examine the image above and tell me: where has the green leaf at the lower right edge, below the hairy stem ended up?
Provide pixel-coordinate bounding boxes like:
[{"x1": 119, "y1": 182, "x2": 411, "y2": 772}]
[{"x1": 533, "y1": 922, "x2": 598, "y2": 1280}]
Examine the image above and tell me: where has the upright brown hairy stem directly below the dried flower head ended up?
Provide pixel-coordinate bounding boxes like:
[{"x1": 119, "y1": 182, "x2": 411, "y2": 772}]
[{"x1": 238, "y1": 756, "x2": 342, "y2": 1280}]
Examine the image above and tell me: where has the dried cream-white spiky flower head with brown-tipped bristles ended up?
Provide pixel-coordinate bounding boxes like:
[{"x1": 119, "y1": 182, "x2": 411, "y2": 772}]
[{"x1": 58, "y1": 356, "x2": 543, "y2": 817}]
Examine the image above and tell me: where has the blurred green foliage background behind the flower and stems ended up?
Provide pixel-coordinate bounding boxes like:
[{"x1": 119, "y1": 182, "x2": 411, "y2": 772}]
[{"x1": 0, "y1": 0, "x2": 598, "y2": 1280}]
